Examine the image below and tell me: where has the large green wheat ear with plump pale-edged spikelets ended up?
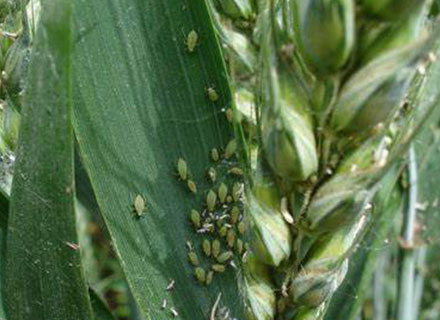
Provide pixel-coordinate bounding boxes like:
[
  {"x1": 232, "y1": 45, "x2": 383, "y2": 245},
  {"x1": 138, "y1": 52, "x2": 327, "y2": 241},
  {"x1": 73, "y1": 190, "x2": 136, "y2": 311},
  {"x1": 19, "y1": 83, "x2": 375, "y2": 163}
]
[{"x1": 211, "y1": 0, "x2": 439, "y2": 320}]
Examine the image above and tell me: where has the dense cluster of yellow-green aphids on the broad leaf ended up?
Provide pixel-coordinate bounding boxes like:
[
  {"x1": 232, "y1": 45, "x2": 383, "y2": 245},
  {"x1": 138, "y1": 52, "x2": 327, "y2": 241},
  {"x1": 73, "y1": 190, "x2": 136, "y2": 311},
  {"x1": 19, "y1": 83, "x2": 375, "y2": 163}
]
[{"x1": 177, "y1": 140, "x2": 248, "y2": 285}]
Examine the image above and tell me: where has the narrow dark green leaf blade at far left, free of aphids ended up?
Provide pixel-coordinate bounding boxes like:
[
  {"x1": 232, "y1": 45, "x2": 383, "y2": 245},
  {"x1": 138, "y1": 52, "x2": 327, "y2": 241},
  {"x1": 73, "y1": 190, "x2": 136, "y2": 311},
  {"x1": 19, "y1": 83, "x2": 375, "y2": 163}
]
[{"x1": 4, "y1": 1, "x2": 93, "y2": 320}]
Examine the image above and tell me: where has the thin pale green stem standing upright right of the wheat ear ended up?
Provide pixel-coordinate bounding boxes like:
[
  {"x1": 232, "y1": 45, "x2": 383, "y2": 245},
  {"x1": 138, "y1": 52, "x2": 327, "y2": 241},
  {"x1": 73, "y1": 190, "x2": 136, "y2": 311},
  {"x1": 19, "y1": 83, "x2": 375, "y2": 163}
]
[{"x1": 397, "y1": 146, "x2": 418, "y2": 320}]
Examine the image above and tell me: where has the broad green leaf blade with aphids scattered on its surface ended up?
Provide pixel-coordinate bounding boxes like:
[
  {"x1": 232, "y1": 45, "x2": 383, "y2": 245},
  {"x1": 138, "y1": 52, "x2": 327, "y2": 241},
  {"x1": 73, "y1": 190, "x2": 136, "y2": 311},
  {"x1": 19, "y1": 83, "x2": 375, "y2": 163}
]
[{"x1": 73, "y1": 0, "x2": 243, "y2": 319}]
